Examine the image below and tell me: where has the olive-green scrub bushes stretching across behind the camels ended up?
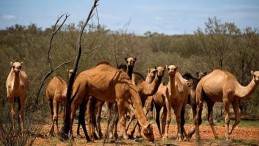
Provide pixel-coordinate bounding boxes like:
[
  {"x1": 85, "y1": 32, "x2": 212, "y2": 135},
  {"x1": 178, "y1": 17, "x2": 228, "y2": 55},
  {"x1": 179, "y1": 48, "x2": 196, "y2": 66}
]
[{"x1": 0, "y1": 17, "x2": 259, "y2": 145}]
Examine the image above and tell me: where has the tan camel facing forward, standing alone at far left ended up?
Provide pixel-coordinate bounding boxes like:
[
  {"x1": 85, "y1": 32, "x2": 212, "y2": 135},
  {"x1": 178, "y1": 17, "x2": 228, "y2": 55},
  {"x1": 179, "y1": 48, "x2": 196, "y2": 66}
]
[{"x1": 6, "y1": 62, "x2": 29, "y2": 133}]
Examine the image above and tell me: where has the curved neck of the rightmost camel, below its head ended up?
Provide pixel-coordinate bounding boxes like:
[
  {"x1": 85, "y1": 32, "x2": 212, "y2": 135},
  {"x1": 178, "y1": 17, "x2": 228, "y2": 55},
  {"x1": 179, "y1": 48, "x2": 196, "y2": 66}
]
[{"x1": 236, "y1": 79, "x2": 258, "y2": 99}]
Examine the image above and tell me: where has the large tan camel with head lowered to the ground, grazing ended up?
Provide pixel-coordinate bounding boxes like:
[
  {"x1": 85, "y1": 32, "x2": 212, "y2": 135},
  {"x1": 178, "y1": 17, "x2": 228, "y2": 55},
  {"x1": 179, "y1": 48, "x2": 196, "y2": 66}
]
[{"x1": 70, "y1": 62, "x2": 154, "y2": 142}]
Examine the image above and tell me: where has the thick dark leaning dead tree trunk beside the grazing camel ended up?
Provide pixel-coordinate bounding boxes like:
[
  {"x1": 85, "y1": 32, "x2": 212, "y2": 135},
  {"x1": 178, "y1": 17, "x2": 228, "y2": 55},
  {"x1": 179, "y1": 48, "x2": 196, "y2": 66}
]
[{"x1": 61, "y1": 0, "x2": 99, "y2": 139}]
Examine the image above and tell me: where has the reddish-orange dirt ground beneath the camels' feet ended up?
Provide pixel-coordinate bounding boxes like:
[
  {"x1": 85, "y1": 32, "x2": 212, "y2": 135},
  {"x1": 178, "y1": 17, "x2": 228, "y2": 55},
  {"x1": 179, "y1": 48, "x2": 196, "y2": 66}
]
[{"x1": 32, "y1": 120, "x2": 259, "y2": 146}]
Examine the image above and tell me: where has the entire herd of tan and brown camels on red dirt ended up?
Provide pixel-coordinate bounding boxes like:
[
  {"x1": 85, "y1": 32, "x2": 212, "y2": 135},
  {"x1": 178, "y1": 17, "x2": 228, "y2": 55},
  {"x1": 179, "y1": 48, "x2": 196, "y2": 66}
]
[{"x1": 6, "y1": 57, "x2": 259, "y2": 142}]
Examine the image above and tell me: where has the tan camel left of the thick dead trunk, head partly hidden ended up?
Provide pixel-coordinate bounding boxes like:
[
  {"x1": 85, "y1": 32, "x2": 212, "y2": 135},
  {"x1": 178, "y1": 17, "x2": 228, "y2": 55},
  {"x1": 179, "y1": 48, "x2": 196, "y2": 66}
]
[{"x1": 46, "y1": 70, "x2": 73, "y2": 136}]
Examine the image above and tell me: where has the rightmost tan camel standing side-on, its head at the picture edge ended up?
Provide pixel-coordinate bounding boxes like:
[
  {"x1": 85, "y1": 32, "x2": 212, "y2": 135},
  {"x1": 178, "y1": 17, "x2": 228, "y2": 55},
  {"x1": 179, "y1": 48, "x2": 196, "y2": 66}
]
[{"x1": 195, "y1": 69, "x2": 259, "y2": 141}]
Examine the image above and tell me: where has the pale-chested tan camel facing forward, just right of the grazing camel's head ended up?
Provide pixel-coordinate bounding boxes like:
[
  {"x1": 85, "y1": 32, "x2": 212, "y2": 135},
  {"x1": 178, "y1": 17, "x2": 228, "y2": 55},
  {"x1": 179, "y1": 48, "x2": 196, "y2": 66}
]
[{"x1": 163, "y1": 65, "x2": 189, "y2": 140}]
